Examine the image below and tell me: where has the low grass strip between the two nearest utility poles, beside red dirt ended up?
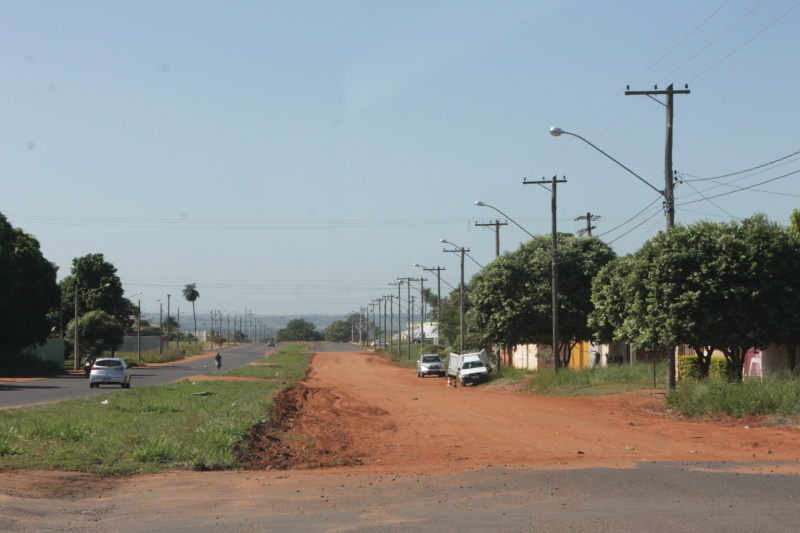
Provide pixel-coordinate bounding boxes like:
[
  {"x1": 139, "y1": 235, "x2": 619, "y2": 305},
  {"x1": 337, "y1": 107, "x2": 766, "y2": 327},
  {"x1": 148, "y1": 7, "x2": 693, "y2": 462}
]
[{"x1": 529, "y1": 362, "x2": 667, "y2": 396}]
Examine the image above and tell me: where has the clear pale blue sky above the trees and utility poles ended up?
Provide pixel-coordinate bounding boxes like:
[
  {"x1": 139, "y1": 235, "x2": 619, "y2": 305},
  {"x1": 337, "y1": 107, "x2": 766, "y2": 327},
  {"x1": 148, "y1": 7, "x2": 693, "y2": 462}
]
[{"x1": 0, "y1": 0, "x2": 800, "y2": 315}]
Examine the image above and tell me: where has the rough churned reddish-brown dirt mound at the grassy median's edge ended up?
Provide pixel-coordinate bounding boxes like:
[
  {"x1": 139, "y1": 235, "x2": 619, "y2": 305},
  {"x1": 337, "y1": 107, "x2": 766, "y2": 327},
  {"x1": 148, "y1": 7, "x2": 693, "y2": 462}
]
[{"x1": 235, "y1": 384, "x2": 387, "y2": 470}]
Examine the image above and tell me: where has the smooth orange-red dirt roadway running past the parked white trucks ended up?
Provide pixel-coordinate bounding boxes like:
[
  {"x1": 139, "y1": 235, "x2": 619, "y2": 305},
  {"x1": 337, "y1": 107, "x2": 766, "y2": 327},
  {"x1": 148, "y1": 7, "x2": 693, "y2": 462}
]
[{"x1": 284, "y1": 353, "x2": 800, "y2": 472}]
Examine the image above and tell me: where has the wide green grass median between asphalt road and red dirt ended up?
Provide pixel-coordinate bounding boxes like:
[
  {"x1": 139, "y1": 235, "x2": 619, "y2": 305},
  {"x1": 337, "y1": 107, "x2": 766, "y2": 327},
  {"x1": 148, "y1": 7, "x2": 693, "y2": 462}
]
[{"x1": 0, "y1": 342, "x2": 308, "y2": 474}]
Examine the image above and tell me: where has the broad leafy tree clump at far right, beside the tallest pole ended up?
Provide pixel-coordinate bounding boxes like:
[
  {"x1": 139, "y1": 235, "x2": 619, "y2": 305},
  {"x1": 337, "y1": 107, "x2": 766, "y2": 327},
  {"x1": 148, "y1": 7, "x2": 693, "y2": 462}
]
[{"x1": 592, "y1": 215, "x2": 800, "y2": 380}]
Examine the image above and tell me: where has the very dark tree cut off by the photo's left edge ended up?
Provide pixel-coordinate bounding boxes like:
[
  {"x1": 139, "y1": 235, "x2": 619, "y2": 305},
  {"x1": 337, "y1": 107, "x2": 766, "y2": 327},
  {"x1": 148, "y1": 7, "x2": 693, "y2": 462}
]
[{"x1": 0, "y1": 213, "x2": 60, "y2": 360}]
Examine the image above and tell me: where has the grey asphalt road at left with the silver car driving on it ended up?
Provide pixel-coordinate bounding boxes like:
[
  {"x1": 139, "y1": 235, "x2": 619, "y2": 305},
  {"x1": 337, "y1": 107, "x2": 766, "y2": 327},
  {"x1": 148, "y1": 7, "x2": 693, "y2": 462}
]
[{"x1": 0, "y1": 343, "x2": 280, "y2": 409}]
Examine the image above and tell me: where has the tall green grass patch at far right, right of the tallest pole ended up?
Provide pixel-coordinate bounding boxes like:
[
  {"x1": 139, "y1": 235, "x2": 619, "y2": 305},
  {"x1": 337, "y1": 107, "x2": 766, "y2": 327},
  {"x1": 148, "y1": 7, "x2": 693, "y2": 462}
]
[{"x1": 666, "y1": 374, "x2": 800, "y2": 417}]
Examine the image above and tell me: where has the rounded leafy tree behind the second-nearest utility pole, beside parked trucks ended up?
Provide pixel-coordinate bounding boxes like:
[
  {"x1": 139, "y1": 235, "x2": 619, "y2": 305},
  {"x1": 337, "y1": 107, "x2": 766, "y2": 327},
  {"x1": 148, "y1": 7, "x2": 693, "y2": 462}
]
[{"x1": 470, "y1": 233, "x2": 615, "y2": 366}]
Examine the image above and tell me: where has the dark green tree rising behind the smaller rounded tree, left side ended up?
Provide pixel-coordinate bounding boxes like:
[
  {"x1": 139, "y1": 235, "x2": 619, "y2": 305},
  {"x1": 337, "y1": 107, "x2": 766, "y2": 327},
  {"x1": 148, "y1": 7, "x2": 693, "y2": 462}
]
[{"x1": 59, "y1": 254, "x2": 136, "y2": 356}]
